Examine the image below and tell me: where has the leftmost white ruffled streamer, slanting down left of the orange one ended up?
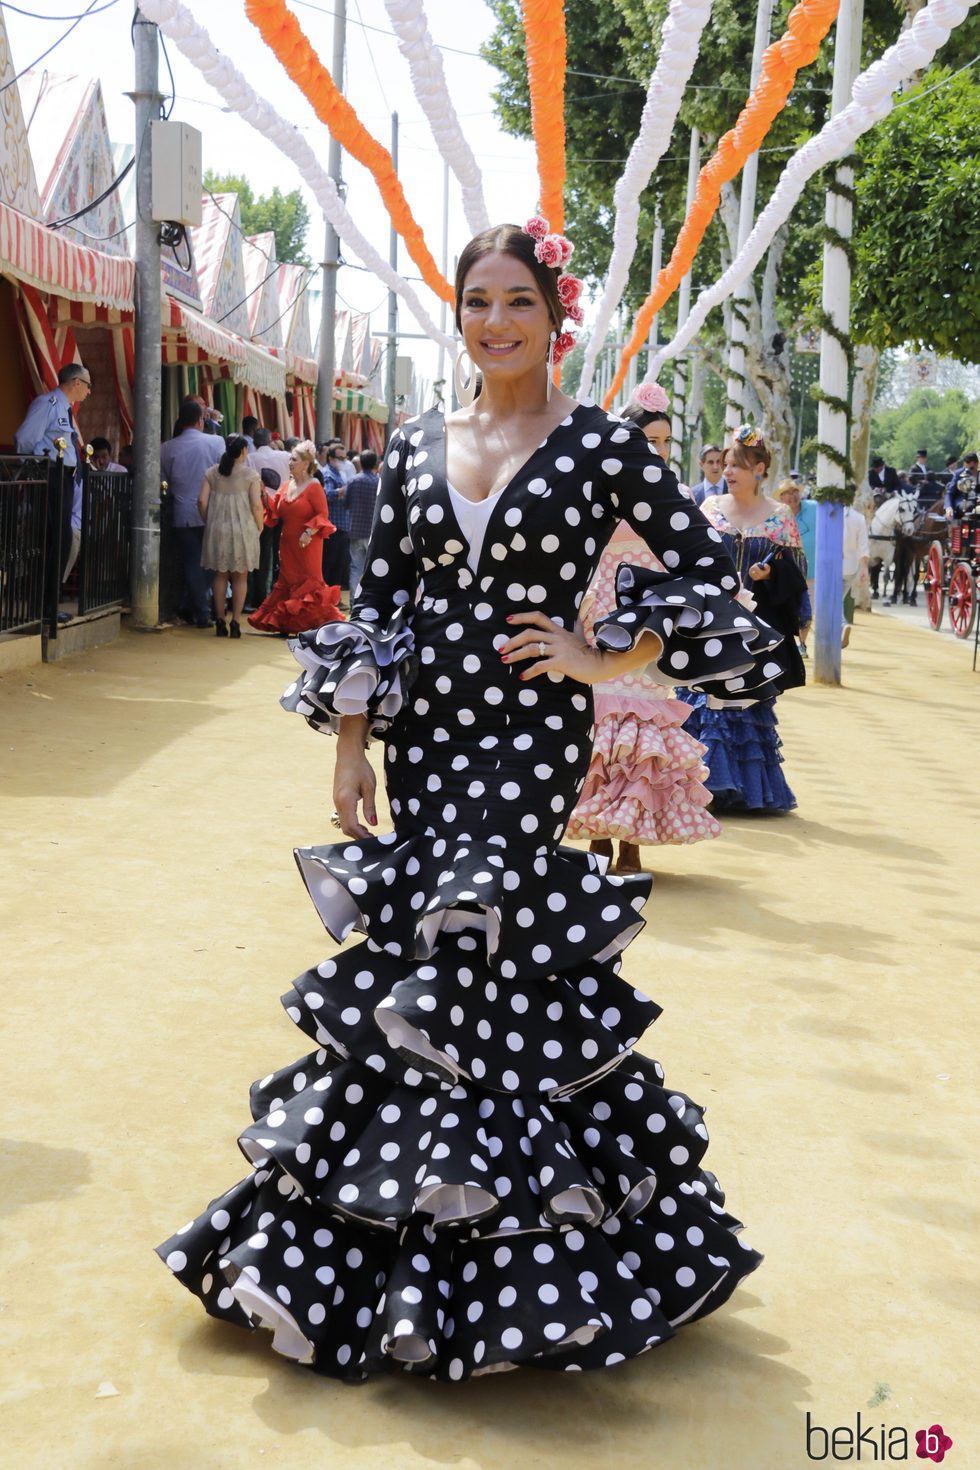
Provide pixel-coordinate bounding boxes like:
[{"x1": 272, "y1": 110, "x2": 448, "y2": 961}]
[{"x1": 140, "y1": 0, "x2": 455, "y2": 359}]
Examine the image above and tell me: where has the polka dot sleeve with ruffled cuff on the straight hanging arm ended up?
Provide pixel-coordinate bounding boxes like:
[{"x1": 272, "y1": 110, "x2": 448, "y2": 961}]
[{"x1": 279, "y1": 431, "x2": 417, "y2": 735}]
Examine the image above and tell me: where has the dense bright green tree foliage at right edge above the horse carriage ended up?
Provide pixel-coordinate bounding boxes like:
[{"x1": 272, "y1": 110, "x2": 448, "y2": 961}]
[{"x1": 851, "y1": 69, "x2": 980, "y2": 363}]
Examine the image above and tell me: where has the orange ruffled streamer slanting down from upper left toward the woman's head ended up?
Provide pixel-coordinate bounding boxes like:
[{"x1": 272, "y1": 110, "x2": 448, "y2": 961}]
[{"x1": 245, "y1": 0, "x2": 455, "y2": 306}]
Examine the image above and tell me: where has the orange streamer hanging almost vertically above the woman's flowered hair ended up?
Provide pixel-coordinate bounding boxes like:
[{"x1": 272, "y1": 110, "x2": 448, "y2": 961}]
[{"x1": 522, "y1": 0, "x2": 566, "y2": 235}]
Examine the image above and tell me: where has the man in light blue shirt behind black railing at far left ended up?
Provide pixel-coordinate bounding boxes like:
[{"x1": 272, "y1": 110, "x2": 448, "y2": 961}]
[{"x1": 15, "y1": 363, "x2": 93, "y2": 598}]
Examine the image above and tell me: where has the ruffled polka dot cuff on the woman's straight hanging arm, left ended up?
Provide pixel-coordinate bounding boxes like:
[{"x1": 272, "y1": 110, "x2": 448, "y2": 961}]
[{"x1": 279, "y1": 606, "x2": 417, "y2": 735}]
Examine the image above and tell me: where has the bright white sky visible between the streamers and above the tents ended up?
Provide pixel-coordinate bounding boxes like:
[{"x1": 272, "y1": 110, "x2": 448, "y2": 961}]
[{"x1": 3, "y1": 0, "x2": 538, "y2": 376}]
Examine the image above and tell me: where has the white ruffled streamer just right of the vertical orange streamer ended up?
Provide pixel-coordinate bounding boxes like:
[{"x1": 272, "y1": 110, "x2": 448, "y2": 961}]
[{"x1": 579, "y1": 0, "x2": 711, "y2": 398}]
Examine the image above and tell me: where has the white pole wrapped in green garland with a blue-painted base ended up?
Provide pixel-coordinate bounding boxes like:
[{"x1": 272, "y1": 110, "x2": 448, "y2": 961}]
[{"x1": 814, "y1": 0, "x2": 864, "y2": 684}]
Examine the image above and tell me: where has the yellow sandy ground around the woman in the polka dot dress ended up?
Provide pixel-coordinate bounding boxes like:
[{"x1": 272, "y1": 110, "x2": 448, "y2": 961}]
[{"x1": 0, "y1": 602, "x2": 980, "y2": 1470}]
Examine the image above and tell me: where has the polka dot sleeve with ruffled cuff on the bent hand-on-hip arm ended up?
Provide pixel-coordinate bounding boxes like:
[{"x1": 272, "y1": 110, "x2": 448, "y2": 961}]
[{"x1": 594, "y1": 419, "x2": 783, "y2": 706}]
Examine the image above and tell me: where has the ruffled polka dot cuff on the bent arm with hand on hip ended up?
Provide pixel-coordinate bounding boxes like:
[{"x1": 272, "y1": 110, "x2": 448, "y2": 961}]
[{"x1": 594, "y1": 564, "x2": 783, "y2": 709}]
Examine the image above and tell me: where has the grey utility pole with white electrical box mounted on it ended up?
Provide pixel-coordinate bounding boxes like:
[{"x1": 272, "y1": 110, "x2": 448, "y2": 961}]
[{"x1": 129, "y1": 10, "x2": 163, "y2": 629}]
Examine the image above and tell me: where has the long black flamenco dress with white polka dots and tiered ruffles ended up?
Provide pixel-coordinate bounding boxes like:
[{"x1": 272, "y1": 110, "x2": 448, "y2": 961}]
[{"x1": 160, "y1": 404, "x2": 780, "y2": 1380}]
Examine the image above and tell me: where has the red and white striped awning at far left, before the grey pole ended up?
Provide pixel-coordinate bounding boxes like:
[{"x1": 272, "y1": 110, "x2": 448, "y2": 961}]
[{"x1": 0, "y1": 201, "x2": 137, "y2": 312}]
